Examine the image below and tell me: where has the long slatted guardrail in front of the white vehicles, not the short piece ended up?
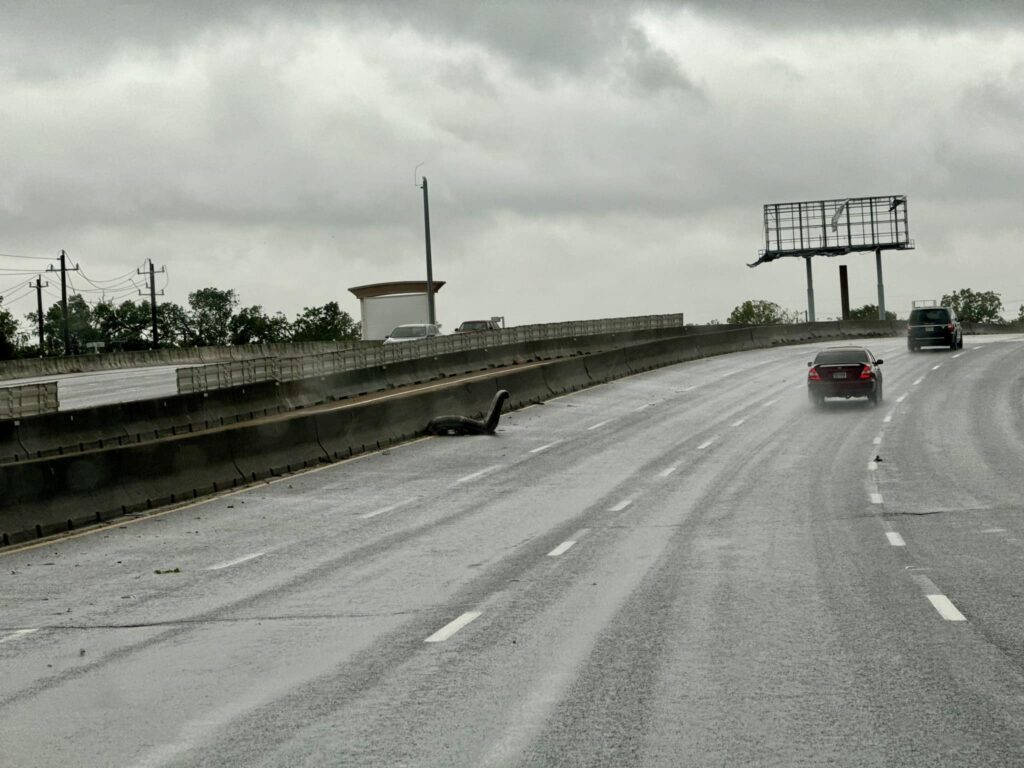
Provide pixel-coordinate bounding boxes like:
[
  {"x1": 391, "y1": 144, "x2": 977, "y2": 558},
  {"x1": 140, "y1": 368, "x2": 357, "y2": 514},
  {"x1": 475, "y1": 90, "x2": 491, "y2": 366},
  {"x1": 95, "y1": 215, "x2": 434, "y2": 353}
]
[{"x1": 177, "y1": 313, "x2": 683, "y2": 394}]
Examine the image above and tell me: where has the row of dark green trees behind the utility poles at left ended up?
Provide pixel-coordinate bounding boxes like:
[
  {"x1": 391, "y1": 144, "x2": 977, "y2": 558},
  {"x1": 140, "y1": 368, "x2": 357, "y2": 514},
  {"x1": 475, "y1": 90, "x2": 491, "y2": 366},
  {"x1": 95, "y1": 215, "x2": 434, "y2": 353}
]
[{"x1": 0, "y1": 288, "x2": 360, "y2": 359}]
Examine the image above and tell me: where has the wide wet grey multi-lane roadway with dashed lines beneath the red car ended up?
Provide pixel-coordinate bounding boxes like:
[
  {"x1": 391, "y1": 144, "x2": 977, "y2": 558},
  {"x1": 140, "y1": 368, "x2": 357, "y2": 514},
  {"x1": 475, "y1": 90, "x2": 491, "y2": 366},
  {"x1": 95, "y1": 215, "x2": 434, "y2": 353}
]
[{"x1": 0, "y1": 337, "x2": 1024, "y2": 766}]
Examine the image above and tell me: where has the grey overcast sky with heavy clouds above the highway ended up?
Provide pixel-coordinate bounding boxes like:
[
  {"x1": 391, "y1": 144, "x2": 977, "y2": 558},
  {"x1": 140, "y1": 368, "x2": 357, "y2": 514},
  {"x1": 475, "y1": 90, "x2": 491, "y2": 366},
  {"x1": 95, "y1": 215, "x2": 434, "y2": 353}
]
[{"x1": 0, "y1": 0, "x2": 1024, "y2": 330}]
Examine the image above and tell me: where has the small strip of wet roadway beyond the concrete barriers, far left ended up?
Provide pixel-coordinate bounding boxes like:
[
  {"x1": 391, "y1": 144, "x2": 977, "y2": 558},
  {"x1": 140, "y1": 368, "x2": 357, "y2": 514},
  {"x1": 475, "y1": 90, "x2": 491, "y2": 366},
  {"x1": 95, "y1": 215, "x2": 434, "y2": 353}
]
[{"x1": 0, "y1": 365, "x2": 190, "y2": 411}]
